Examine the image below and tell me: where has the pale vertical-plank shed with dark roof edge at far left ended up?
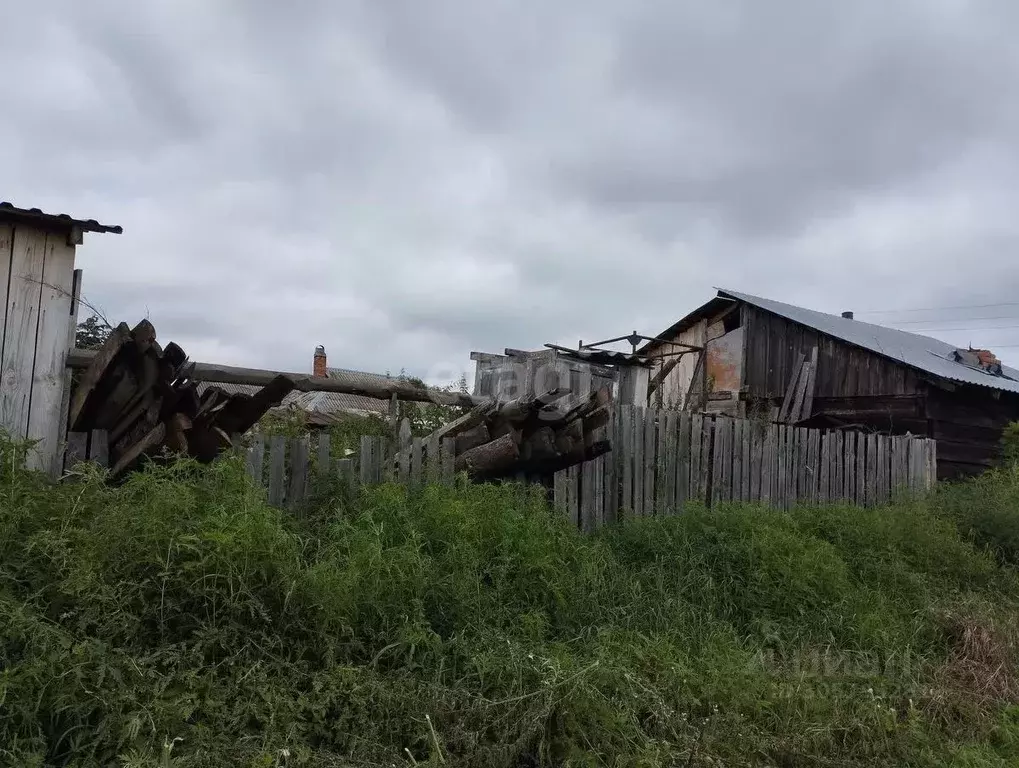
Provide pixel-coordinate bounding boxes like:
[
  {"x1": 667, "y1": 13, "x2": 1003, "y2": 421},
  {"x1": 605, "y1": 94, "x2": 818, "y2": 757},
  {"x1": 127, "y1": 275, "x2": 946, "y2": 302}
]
[{"x1": 0, "y1": 203, "x2": 122, "y2": 472}]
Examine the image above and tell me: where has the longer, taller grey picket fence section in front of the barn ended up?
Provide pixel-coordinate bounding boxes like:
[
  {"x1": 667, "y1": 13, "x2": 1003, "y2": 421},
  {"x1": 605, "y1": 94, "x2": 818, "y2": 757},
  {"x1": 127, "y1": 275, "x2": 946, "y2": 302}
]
[{"x1": 554, "y1": 405, "x2": 936, "y2": 531}]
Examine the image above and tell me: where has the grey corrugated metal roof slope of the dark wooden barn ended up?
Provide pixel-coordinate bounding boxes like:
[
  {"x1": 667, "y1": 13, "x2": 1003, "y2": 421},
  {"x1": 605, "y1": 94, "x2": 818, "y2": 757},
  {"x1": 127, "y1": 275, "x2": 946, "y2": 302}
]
[{"x1": 718, "y1": 288, "x2": 1019, "y2": 392}]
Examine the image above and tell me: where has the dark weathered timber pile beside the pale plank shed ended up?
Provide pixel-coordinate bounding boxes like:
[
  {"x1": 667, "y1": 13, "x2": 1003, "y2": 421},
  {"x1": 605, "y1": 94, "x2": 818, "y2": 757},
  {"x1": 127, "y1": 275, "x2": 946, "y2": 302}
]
[{"x1": 68, "y1": 320, "x2": 293, "y2": 477}]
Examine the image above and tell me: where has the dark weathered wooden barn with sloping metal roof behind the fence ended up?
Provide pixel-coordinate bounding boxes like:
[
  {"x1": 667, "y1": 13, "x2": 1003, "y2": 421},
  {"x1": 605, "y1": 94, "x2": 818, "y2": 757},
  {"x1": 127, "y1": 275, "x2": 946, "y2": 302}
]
[{"x1": 640, "y1": 290, "x2": 1019, "y2": 479}]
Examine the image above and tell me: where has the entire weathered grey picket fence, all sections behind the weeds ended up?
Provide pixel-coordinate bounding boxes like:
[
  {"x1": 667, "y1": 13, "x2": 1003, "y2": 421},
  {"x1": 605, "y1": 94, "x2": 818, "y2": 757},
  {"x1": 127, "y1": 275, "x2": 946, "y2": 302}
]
[{"x1": 65, "y1": 405, "x2": 936, "y2": 531}]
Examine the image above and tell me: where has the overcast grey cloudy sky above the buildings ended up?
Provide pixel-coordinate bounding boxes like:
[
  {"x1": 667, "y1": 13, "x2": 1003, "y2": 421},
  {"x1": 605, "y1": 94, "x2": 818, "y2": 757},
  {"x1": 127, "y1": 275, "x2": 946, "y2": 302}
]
[{"x1": 0, "y1": 0, "x2": 1019, "y2": 382}]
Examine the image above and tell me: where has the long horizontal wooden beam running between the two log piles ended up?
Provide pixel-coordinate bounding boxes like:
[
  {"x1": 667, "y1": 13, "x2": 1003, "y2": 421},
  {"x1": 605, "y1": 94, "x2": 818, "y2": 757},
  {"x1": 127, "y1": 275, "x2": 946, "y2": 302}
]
[{"x1": 67, "y1": 349, "x2": 490, "y2": 407}]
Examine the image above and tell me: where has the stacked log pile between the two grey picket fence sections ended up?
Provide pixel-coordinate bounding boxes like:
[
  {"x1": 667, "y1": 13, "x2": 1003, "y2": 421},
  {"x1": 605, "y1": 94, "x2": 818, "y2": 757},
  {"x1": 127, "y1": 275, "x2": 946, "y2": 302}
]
[{"x1": 395, "y1": 388, "x2": 611, "y2": 481}]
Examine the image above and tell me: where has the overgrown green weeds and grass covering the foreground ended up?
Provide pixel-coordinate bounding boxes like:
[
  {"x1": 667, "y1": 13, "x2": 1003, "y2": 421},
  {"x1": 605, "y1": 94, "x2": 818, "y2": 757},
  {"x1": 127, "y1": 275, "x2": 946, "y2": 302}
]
[{"x1": 0, "y1": 431, "x2": 1019, "y2": 767}]
